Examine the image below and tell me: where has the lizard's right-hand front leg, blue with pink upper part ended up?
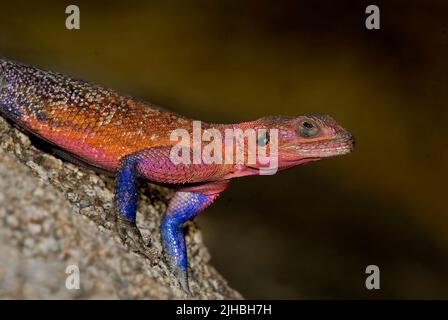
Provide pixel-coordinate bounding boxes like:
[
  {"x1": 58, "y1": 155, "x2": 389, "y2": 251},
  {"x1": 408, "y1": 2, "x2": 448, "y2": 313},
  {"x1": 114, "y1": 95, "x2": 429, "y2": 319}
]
[{"x1": 160, "y1": 181, "x2": 227, "y2": 292}]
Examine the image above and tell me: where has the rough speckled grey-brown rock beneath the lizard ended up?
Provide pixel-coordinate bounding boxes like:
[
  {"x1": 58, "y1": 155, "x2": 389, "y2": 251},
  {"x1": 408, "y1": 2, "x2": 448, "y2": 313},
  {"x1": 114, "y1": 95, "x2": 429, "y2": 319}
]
[{"x1": 0, "y1": 117, "x2": 241, "y2": 299}]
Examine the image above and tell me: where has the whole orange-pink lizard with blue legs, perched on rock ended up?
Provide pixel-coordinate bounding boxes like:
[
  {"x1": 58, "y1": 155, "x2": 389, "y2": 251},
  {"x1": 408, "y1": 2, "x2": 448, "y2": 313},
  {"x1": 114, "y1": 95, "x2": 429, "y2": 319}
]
[{"x1": 0, "y1": 59, "x2": 354, "y2": 292}]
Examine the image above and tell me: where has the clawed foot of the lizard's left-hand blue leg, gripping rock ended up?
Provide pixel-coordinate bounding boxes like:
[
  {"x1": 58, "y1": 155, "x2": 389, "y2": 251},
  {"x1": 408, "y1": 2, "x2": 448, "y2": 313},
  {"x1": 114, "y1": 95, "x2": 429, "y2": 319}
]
[{"x1": 117, "y1": 217, "x2": 155, "y2": 259}]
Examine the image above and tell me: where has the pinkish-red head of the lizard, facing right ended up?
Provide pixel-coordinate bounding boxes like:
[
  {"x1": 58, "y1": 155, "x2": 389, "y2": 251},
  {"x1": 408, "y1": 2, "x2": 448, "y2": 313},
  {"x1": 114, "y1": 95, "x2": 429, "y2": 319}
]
[{"x1": 236, "y1": 114, "x2": 355, "y2": 174}]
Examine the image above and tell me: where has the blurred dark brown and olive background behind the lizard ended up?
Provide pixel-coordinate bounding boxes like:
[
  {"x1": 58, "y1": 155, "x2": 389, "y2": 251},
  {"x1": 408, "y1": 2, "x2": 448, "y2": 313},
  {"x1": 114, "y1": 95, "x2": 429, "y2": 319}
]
[{"x1": 0, "y1": 0, "x2": 448, "y2": 298}]
